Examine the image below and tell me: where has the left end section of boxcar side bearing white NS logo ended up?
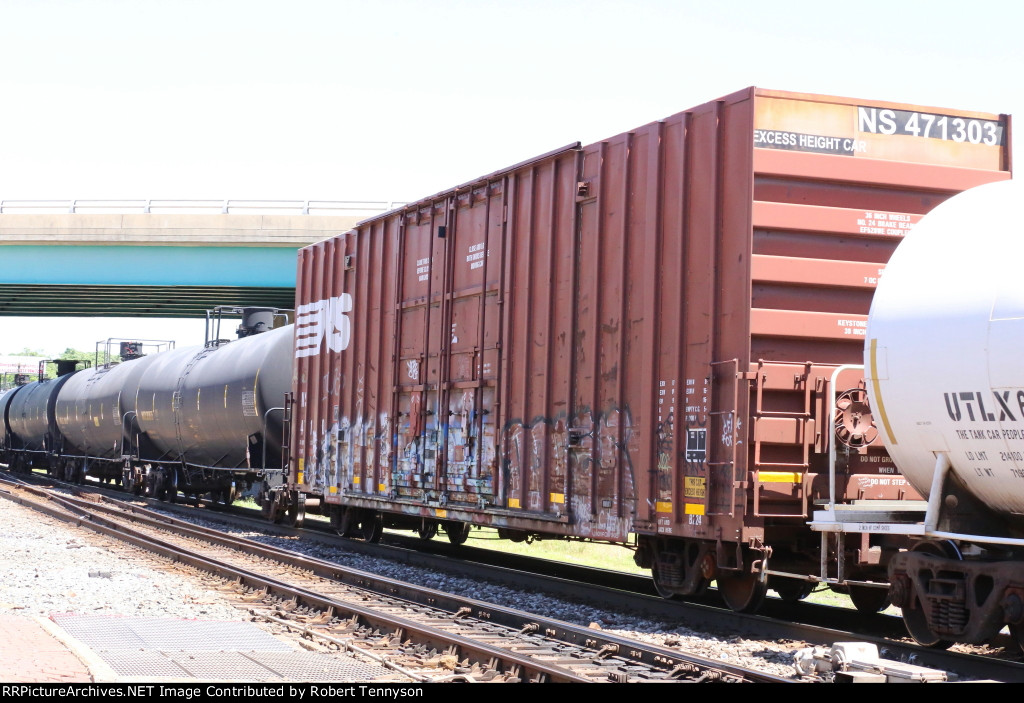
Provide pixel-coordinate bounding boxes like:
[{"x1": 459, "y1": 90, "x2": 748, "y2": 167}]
[{"x1": 290, "y1": 212, "x2": 397, "y2": 503}]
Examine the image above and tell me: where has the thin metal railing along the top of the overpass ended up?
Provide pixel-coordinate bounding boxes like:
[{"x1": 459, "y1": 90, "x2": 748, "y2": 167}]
[{"x1": 0, "y1": 200, "x2": 406, "y2": 217}]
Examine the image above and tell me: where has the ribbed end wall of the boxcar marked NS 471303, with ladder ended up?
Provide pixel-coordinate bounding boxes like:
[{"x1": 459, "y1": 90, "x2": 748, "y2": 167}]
[{"x1": 737, "y1": 91, "x2": 1010, "y2": 539}]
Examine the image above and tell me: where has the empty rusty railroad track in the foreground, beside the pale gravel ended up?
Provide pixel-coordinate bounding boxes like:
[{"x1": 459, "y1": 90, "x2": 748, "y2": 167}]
[{"x1": 5, "y1": 474, "x2": 788, "y2": 683}]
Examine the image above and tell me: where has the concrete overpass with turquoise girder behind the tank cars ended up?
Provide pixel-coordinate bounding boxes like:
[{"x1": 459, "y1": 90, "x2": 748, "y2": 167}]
[{"x1": 0, "y1": 201, "x2": 402, "y2": 317}]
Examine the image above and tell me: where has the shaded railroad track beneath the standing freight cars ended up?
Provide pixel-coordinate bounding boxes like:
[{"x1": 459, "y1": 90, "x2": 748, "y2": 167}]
[{"x1": 8, "y1": 466, "x2": 1024, "y2": 682}]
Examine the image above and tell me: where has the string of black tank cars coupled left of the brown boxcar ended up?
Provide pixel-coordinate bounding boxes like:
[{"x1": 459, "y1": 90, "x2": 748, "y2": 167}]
[{"x1": 0, "y1": 309, "x2": 292, "y2": 502}]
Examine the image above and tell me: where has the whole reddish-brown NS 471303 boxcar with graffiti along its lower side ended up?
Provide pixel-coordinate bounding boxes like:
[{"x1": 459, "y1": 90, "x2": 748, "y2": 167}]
[{"x1": 287, "y1": 88, "x2": 1010, "y2": 609}]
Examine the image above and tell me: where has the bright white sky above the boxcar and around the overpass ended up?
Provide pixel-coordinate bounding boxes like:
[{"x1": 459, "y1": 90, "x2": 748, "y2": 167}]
[{"x1": 0, "y1": 0, "x2": 1024, "y2": 352}]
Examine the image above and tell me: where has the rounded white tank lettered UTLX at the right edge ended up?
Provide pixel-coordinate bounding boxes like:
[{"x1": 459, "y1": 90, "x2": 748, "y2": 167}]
[{"x1": 864, "y1": 176, "x2": 1024, "y2": 515}]
